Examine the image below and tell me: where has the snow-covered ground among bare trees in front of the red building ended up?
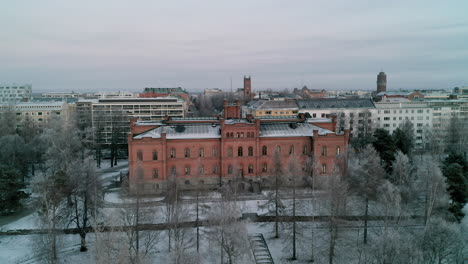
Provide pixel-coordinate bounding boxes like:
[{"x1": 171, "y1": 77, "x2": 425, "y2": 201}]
[{"x1": 0, "y1": 189, "x2": 468, "y2": 264}]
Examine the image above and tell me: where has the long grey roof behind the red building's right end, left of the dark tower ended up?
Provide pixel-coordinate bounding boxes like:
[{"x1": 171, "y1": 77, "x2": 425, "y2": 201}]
[{"x1": 297, "y1": 98, "x2": 375, "y2": 109}]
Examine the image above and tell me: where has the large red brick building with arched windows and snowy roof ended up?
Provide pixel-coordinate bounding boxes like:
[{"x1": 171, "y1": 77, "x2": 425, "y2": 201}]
[{"x1": 128, "y1": 103, "x2": 349, "y2": 192}]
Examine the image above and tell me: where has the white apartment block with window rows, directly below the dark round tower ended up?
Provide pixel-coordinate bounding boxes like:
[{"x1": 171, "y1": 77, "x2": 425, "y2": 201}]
[{"x1": 375, "y1": 101, "x2": 433, "y2": 148}]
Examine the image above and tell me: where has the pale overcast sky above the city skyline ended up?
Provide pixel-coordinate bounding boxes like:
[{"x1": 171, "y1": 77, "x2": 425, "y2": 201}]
[{"x1": 0, "y1": 0, "x2": 468, "y2": 92}]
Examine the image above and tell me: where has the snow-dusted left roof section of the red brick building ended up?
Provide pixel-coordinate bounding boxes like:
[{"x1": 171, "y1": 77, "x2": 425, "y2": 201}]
[{"x1": 134, "y1": 124, "x2": 221, "y2": 139}]
